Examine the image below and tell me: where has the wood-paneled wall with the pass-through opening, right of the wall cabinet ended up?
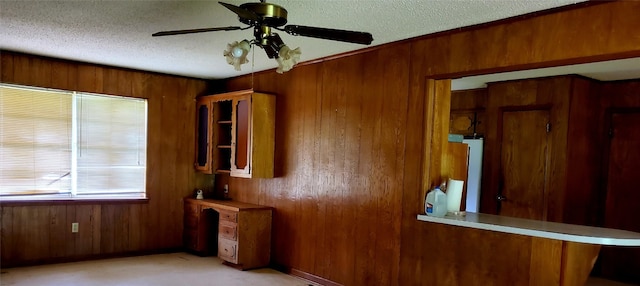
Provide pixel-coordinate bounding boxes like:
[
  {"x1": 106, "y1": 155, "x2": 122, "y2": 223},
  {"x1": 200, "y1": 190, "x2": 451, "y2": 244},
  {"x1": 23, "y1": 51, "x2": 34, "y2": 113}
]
[{"x1": 220, "y1": 1, "x2": 640, "y2": 285}]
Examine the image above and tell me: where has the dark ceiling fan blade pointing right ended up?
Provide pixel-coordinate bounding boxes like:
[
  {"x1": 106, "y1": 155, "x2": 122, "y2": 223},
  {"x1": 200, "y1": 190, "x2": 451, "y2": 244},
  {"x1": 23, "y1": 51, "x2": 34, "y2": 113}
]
[{"x1": 284, "y1": 25, "x2": 373, "y2": 45}]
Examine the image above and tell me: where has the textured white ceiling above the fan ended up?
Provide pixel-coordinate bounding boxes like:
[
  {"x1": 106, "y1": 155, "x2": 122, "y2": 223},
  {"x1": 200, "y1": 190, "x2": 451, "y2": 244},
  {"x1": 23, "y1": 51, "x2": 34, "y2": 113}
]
[{"x1": 0, "y1": 0, "x2": 582, "y2": 79}]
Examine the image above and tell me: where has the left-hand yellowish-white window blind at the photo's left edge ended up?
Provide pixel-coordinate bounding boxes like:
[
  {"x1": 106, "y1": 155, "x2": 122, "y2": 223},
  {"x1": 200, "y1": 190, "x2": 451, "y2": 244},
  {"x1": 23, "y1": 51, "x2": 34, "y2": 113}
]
[{"x1": 0, "y1": 86, "x2": 72, "y2": 196}]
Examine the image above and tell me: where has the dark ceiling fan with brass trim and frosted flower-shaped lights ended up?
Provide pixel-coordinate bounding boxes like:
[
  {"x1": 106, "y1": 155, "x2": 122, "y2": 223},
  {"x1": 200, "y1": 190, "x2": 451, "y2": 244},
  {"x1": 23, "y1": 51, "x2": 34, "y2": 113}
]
[{"x1": 152, "y1": 0, "x2": 373, "y2": 72}]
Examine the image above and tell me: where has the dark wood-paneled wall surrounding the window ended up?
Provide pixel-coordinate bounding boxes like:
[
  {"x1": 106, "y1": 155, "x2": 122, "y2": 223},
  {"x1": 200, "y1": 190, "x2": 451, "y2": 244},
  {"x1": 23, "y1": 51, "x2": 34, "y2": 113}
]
[{"x1": 0, "y1": 51, "x2": 212, "y2": 267}]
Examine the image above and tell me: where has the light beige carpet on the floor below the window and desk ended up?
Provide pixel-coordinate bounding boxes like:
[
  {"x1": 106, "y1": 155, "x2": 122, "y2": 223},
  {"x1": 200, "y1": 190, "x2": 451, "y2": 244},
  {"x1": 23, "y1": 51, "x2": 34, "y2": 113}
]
[{"x1": 0, "y1": 253, "x2": 315, "y2": 286}]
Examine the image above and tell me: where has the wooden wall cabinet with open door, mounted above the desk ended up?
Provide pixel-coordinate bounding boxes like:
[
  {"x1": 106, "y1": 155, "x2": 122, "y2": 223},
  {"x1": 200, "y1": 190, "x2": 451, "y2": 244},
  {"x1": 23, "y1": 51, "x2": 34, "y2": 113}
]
[{"x1": 195, "y1": 90, "x2": 276, "y2": 178}]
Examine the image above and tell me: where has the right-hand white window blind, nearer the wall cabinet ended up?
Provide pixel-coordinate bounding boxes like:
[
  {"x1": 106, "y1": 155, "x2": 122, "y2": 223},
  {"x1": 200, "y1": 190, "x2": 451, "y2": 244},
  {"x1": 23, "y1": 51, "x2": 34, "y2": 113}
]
[{"x1": 76, "y1": 94, "x2": 147, "y2": 197}]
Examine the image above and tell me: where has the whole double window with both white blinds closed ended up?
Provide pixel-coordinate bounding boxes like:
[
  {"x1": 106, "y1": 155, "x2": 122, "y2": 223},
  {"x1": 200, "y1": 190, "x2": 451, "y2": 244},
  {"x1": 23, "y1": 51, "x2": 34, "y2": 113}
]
[{"x1": 0, "y1": 84, "x2": 147, "y2": 200}]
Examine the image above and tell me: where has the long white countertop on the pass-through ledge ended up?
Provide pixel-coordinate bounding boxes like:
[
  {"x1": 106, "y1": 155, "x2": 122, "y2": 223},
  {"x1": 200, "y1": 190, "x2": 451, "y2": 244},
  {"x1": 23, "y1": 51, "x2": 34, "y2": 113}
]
[{"x1": 418, "y1": 212, "x2": 640, "y2": 246}]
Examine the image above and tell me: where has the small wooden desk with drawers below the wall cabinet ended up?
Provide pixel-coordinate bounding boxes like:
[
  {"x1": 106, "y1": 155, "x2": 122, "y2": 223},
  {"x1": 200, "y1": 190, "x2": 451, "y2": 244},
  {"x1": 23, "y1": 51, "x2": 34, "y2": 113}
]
[{"x1": 184, "y1": 198, "x2": 272, "y2": 270}]
